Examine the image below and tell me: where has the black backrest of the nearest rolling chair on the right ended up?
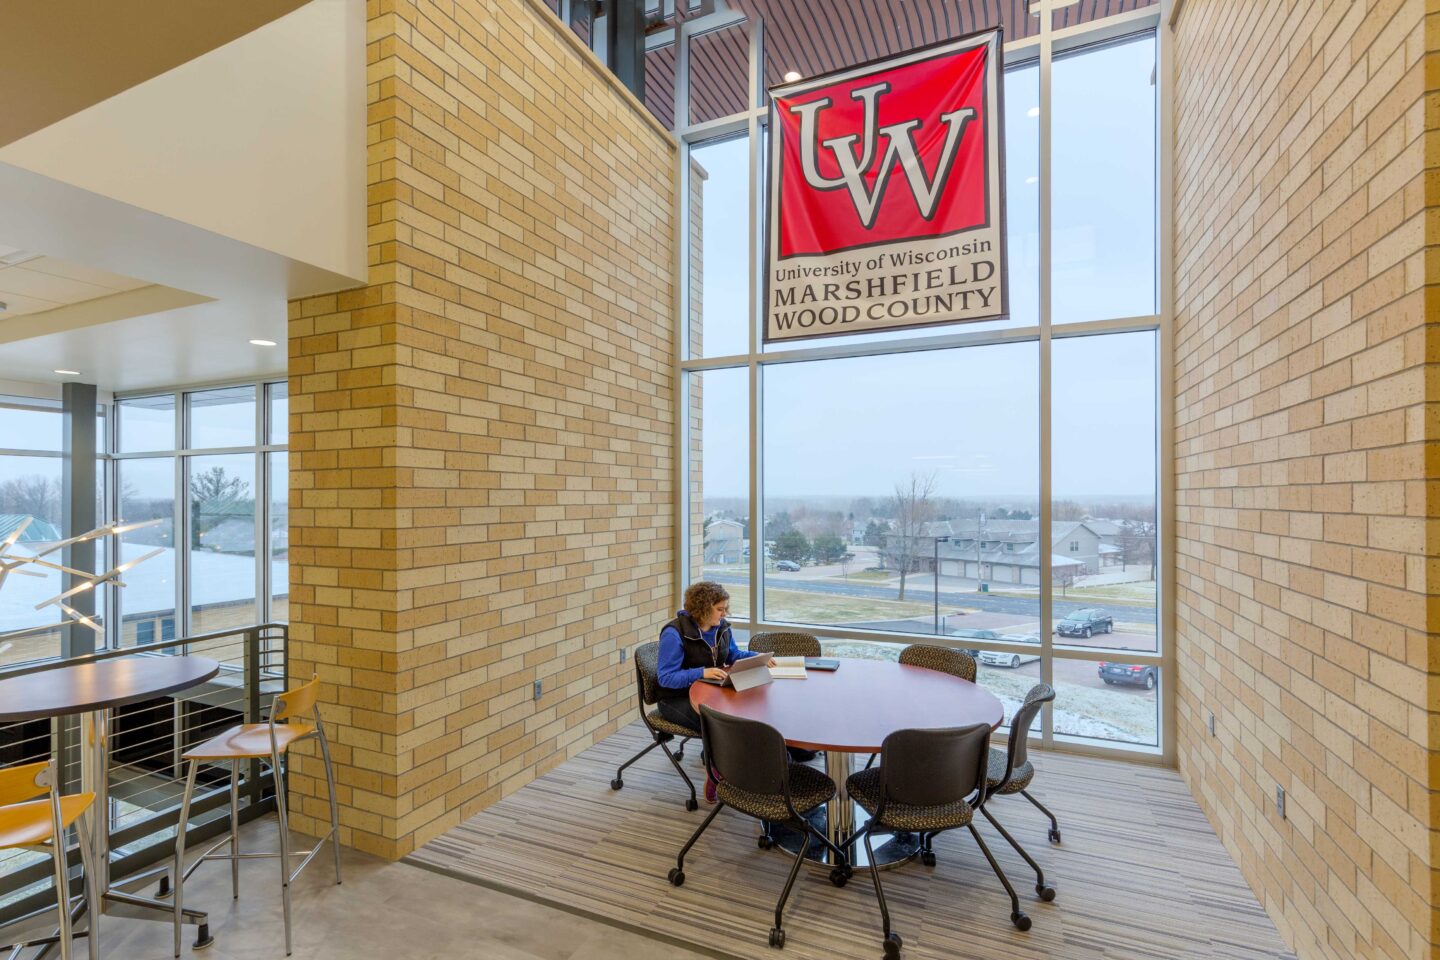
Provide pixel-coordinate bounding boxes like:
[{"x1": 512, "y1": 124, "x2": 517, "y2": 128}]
[{"x1": 880, "y1": 724, "x2": 991, "y2": 806}]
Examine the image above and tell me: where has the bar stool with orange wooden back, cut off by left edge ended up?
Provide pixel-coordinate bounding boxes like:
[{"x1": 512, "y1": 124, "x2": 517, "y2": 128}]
[{"x1": 0, "y1": 760, "x2": 101, "y2": 960}]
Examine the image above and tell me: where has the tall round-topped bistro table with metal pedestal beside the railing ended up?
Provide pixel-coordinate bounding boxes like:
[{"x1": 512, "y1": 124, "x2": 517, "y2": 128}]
[{"x1": 0, "y1": 655, "x2": 220, "y2": 947}]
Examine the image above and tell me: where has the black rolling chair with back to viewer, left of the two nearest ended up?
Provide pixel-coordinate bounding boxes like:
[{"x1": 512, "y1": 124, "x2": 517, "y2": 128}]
[{"x1": 667, "y1": 707, "x2": 851, "y2": 947}]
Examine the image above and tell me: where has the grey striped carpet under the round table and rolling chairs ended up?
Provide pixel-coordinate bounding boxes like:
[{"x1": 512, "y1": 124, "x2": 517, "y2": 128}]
[{"x1": 406, "y1": 721, "x2": 1293, "y2": 960}]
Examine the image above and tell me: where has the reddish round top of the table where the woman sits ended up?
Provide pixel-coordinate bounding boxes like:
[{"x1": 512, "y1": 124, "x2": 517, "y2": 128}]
[{"x1": 690, "y1": 659, "x2": 1005, "y2": 753}]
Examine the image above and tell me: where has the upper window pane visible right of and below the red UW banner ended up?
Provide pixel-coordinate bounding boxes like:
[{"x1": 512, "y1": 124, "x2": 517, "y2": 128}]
[{"x1": 766, "y1": 66, "x2": 1040, "y2": 356}]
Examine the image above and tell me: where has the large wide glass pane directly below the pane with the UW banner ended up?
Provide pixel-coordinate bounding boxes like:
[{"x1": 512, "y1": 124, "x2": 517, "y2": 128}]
[{"x1": 763, "y1": 343, "x2": 1040, "y2": 639}]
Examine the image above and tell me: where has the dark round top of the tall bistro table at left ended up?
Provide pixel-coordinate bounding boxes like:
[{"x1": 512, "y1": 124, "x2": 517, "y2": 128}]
[{"x1": 0, "y1": 656, "x2": 220, "y2": 723}]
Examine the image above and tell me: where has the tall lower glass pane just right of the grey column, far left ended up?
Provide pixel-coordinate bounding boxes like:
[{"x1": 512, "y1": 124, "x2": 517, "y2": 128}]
[{"x1": 115, "y1": 456, "x2": 177, "y2": 646}]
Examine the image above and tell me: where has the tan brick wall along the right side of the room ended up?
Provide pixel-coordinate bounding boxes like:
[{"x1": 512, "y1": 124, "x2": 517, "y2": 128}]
[{"x1": 1175, "y1": 0, "x2": 1440, "y2": 960}]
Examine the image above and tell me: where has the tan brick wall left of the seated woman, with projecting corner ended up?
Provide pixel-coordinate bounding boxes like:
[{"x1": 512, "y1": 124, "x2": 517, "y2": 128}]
[{"x1": 289, "y1": 0, "x2": 675, "y2": 856}]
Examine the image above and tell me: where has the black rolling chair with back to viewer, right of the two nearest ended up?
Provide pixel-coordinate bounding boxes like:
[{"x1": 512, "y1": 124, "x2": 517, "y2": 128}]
[{"x1": 845, "y1": 724, "x2": 1030, "y2": 960}]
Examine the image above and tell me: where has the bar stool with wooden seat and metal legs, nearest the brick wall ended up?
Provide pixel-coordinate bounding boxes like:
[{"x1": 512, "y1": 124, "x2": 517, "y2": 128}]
[{"x1": 173, "y1": 676, "x2": 340, "y2": 957}]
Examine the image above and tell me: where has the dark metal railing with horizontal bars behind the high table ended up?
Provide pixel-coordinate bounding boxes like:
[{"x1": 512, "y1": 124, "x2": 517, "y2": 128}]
[{"x1": 0, "y1": 623, "x2": 289, "y2": 925}]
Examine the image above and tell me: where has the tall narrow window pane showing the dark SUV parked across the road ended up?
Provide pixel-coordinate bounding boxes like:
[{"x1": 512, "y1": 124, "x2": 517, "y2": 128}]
[{"x1": 1051, "y1": 331, "x2": 1159, "y2": 652}]
